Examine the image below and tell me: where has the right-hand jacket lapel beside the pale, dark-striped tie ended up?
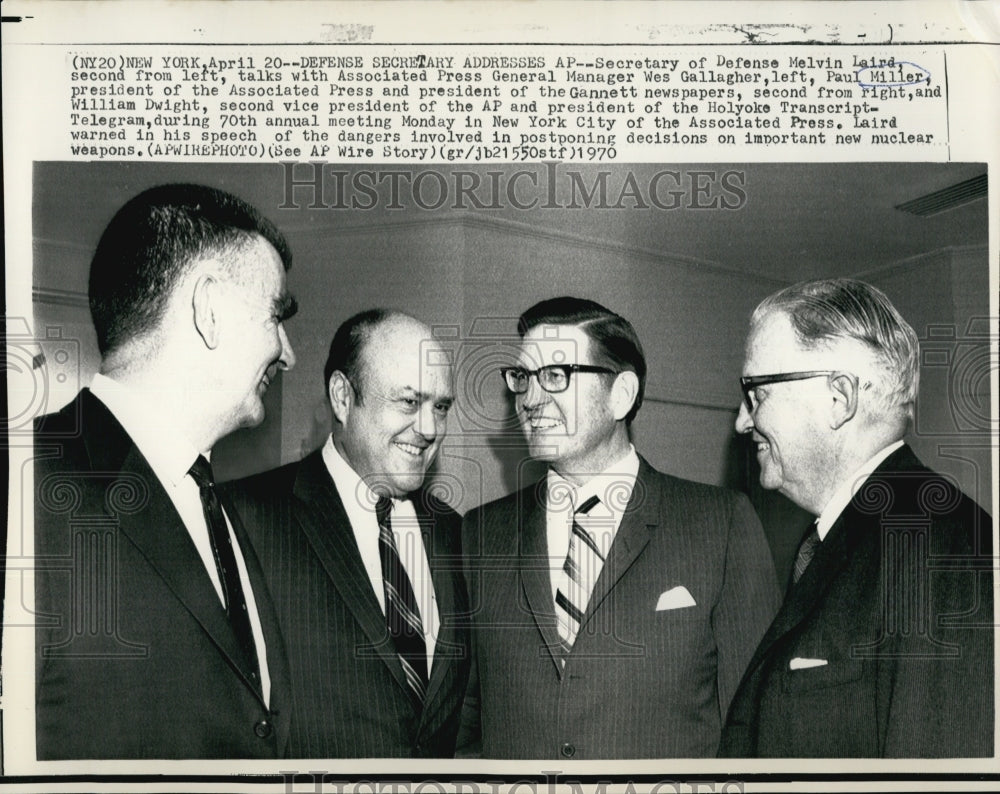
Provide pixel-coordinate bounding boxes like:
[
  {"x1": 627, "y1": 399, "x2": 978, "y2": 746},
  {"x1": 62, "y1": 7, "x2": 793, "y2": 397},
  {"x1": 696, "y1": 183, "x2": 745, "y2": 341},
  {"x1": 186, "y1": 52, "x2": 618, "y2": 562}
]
[{"x1": 580, "y1": 458, "x2": 661, "y2": 631}]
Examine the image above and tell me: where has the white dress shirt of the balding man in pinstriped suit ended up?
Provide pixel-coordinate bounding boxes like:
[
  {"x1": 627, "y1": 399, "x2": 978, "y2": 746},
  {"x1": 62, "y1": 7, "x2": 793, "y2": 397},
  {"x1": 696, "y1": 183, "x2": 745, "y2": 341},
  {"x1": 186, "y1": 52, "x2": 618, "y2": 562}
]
[{"x1": 322, "y1": 436, "x2": 441, "y2": 675}]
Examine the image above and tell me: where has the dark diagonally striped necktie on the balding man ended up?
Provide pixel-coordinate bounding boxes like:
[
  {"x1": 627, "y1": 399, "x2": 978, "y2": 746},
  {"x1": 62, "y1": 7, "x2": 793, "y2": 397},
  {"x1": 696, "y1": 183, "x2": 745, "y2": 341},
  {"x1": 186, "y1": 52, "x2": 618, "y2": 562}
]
[{"x1": 375, "y1": 496, "x2": 427, "y2": 704}]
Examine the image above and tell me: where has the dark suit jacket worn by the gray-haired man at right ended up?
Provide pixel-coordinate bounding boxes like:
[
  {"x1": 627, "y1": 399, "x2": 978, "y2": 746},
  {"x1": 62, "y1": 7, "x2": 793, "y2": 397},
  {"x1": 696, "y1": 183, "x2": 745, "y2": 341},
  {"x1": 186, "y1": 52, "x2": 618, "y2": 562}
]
[{"x1": 720, "y1": 446, "x2": 994, "y2": 758}]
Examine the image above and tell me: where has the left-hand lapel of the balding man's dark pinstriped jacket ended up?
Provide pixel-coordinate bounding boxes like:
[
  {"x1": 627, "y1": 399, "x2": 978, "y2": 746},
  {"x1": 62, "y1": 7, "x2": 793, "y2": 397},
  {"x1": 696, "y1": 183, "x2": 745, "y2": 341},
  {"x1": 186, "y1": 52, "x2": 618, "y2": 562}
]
[{"x1": 294, "y1": 451, "x2": 409, "y2": 692}]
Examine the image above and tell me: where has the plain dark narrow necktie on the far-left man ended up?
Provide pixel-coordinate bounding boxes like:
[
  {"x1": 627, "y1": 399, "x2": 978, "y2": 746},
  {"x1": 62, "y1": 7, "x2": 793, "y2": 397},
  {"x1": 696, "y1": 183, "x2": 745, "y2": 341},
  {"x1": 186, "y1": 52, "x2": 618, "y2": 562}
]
[{"x1": 189, "y1": 455, "x2": 260, "y2": 687}]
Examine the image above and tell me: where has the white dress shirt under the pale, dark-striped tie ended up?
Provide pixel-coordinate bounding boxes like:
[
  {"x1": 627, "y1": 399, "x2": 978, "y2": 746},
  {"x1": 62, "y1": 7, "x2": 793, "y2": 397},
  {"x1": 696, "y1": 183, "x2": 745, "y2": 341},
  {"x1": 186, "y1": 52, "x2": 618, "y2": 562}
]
[{"x1": 545, "y1": 444, "x2": 639, "y2": 603}]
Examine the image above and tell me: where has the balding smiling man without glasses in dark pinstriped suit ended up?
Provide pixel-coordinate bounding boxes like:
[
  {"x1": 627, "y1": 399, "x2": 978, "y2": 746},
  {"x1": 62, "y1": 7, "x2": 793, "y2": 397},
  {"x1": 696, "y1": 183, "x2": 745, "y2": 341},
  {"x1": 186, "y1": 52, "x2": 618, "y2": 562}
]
[{"x1": 234, "y1": 309, "x2": 469, "y2": 758}]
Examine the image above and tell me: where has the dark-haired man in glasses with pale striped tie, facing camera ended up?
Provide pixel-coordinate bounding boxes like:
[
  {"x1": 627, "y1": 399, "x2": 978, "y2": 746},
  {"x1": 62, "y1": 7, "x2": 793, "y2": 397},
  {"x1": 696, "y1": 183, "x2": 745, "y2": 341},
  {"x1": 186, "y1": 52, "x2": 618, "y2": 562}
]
[{"x1": 462, "y1": 298, "x2": 779, "y2": 759}]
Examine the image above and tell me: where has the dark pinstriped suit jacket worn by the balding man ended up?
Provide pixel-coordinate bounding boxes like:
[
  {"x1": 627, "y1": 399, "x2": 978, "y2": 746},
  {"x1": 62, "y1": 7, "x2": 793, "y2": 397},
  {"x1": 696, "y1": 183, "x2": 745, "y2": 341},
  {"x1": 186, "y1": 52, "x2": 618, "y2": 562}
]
[{"x1": 232, "y1": 451, "x2": 469, "y2": 758}]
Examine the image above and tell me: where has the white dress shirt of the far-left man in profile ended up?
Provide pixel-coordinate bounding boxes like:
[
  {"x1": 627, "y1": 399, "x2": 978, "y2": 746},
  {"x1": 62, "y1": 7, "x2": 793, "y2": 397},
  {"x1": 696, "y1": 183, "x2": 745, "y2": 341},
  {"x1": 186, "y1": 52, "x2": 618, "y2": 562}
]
[{"x1": 90, "y1": 373, "x2": 271, "y2": 703}]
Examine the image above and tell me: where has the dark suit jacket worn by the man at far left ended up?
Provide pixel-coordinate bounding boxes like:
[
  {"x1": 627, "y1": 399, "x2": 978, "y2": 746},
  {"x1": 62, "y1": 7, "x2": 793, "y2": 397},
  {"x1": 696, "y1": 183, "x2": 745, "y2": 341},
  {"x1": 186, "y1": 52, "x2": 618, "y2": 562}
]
[{"x1": 35, "y1": 389, "x2": 289, "y2": 759}]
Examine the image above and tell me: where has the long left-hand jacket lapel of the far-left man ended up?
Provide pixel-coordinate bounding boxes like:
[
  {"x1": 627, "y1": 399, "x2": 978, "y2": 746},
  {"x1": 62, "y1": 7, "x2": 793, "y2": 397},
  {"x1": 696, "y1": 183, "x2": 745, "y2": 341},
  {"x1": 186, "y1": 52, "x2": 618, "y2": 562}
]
[{"x1": 81, "y1": 391, "x2": 260, "y2": 698}]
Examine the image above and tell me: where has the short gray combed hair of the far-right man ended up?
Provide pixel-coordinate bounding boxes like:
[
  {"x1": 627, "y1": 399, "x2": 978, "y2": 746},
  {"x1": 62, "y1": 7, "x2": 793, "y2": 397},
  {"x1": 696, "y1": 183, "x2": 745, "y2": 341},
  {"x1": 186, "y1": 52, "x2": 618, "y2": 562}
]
[{"x1": 750, "y1": 278, "x2": 920, "y2": 418}]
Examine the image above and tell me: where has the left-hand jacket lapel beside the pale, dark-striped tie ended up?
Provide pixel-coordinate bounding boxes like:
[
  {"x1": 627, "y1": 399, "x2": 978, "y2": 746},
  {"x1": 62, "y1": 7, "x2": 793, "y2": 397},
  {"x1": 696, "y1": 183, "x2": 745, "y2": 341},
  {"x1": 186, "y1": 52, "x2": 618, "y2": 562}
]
[{"x1": 516, "y1": 479, "x2": 562, "y2": 676}]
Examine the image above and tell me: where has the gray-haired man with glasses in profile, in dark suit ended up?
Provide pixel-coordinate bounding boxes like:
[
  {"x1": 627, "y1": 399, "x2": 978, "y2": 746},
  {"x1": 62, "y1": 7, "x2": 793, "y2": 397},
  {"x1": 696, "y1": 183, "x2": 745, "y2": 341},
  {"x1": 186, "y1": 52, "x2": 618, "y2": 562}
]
[{"x1": 720, "y1": 279, "x2": 995, "y2": 758}]
